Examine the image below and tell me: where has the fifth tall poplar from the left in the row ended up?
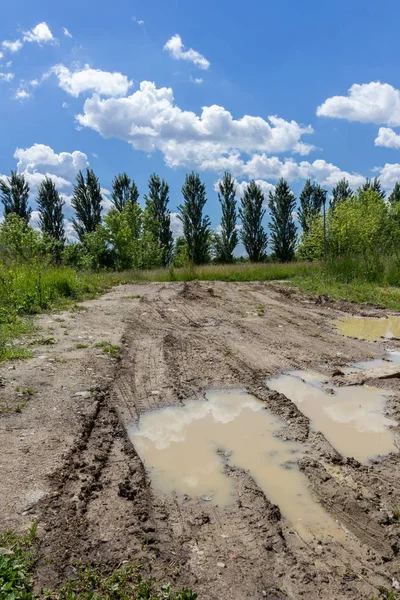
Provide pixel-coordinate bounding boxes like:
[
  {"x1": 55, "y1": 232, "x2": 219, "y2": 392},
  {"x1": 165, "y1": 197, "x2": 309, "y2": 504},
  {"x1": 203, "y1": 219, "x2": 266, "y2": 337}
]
[{"x1": 144, "y1": 173, "x2": 174, "y2": 267}]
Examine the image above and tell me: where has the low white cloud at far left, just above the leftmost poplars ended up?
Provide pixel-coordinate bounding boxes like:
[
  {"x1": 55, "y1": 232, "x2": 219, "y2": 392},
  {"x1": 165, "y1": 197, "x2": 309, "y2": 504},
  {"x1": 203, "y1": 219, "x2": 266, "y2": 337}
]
[{"x1": 14, "y1": 144, "x2": 89, "y2": 179}]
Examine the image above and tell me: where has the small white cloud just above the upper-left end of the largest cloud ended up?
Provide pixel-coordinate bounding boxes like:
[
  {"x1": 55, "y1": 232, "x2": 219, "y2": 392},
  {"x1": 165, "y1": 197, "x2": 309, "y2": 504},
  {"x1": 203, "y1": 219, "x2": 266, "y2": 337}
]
[{"x1": 51, "y1": 65, "x2": 132, "y2": 98}]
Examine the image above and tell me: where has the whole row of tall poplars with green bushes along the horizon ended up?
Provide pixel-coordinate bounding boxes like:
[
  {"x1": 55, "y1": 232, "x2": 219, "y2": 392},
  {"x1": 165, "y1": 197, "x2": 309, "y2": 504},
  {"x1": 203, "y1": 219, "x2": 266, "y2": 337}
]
[{"x1": 0, "y1": 169, "x2": 400, "y2": 269}]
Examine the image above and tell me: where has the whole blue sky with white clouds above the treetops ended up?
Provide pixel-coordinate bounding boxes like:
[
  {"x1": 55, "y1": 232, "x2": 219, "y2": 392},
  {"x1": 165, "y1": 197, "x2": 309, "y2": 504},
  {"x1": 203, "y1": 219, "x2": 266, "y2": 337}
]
[{"x1": 0, "y1": 0, "x2": 400, "y2": 239}]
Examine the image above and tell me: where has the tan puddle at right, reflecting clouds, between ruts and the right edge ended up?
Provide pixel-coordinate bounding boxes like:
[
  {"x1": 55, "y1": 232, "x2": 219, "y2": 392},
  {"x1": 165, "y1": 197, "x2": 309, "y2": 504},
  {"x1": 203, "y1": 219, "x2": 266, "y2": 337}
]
[{"x1": 267, "y1": 371, "x2": 397, "y2": 462}]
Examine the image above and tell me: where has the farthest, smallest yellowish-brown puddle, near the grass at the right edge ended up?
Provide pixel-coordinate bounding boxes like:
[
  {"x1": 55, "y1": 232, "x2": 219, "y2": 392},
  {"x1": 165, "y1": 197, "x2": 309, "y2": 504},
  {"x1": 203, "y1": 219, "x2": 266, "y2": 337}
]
[{"x1": 335, "y1": 317, "x2": 400, "y2": 342}]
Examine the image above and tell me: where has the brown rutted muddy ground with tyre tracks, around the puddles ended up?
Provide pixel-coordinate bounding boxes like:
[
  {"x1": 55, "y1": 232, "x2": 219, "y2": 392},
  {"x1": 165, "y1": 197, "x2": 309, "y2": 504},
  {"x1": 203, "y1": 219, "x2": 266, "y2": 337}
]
[{"x1": 0, "y1": 282, "x2": 400, "y2": 600}]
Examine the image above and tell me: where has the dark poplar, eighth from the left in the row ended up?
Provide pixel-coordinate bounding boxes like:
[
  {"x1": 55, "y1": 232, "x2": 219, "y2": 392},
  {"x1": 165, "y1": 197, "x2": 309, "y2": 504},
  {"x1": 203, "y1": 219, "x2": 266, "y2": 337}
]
[{"x1": 239, "y1": 181, "x2": 268, "y2": 262}]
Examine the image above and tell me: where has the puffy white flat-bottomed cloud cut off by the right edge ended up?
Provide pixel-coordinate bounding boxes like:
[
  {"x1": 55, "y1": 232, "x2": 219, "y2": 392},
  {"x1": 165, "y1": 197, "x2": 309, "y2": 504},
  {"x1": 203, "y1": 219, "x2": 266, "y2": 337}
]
[{"x1": 317, "y1": 81, "x2": 400, "y2": 126}]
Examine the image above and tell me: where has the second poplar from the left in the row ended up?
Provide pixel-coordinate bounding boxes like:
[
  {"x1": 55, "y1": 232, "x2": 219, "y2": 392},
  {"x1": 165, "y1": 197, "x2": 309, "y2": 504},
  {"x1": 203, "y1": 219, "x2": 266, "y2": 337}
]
[{"x1": 36, "y1": 177, "x2": 65, "y2": 244}]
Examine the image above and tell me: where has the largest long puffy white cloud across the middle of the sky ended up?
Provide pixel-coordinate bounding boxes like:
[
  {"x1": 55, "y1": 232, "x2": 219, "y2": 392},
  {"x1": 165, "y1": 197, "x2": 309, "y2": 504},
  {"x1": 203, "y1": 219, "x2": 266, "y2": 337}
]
[{"x1": 77, "y1": 81, "x2": 313, "y2": 171}]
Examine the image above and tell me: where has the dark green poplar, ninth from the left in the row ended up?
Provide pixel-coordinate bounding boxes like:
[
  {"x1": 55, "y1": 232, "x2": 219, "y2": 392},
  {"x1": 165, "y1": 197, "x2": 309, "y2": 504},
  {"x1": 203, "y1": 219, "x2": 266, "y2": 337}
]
[{"x1": 268, "y1": 179, "x2": 296, "y2": 262}]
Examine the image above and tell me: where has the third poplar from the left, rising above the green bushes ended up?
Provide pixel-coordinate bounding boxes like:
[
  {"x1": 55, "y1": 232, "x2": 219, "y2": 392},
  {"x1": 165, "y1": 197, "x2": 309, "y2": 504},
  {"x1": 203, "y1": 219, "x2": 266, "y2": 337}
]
[{"x1": 71, "y1": 169, "x2": 102, "y2": 241}]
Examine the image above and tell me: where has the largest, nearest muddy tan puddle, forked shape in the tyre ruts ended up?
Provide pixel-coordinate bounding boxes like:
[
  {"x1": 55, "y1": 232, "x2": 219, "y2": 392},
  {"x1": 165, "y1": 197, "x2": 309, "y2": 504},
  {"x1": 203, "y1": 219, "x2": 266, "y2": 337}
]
[{"x1": 128, "y1": 391, "x2": 344, "y2": 539}]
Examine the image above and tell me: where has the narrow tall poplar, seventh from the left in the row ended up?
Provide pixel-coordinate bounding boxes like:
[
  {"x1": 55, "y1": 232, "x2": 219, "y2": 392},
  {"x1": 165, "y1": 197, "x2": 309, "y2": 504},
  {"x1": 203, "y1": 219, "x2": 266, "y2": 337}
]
[{"x1": 214, "y1": 172, "x2": 239, "y2": 263}]
